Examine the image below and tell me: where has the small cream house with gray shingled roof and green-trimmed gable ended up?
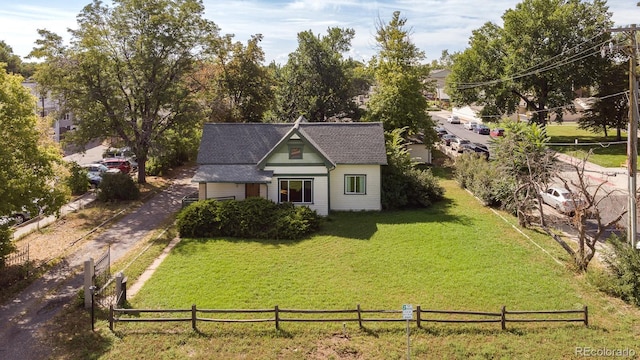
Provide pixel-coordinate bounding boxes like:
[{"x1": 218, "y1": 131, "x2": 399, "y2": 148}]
[{"x1": 192, "y1": 117, "x2": 387, "y2": 215}]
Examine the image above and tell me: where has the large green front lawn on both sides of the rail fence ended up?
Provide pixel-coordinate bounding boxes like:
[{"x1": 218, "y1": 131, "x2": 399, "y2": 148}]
[{"x1": 93, "y1": 175, "x2": 640, "y2": 359}]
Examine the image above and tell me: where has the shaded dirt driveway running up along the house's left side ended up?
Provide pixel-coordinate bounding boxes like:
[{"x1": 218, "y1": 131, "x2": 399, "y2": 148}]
[{"x1": 0, "y1": 169, "x2": 197, "y2": 359}]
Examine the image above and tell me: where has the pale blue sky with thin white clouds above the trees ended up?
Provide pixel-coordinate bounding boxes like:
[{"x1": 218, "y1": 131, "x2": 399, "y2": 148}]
[{"x1": 0, "y1": 0, "x2": 640, "y2": 64}]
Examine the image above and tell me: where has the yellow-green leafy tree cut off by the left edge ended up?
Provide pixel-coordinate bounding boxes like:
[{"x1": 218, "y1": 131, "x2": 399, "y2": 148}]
[{"x1": 0, "y1": 65, "x2": 69, "y2": 264}]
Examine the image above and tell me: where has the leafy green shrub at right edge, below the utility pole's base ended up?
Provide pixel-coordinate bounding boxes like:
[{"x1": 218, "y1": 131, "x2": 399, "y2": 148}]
[{"x1": 600, "y1": 236, "x2": 640, "y2": 306}]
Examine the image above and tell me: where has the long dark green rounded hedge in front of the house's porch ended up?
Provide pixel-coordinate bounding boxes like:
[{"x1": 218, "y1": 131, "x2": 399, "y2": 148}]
[{"x1": 177, "y1": 197, "x2": 320, "y2": 239}]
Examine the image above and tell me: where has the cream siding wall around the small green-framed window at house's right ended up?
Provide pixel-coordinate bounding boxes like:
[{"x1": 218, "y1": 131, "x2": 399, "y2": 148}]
[{"x1": 330, "y1": 165, "x2": 382, "y2": 210}]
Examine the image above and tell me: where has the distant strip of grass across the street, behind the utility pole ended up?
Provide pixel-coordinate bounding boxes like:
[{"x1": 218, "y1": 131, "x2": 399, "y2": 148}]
[{"x1": 547, "y1": 123, "x2": 627, "y2": 167}]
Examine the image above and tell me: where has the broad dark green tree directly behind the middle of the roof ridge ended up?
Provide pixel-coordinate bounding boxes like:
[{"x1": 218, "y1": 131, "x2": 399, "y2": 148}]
[{"x1": 276, "y1": 28, "x2": 357, "y2": 121}]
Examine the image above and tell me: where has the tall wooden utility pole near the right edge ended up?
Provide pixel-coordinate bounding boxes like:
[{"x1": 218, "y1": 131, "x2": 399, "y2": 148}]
[{"x1": 610, "y1": 24, "x2": 640, "y2": 248}]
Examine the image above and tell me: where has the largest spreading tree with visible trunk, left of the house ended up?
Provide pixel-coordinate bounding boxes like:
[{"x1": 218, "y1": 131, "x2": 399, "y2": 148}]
[{"x1": 32, "y1": 0, "x2": 218, "y2": 183}]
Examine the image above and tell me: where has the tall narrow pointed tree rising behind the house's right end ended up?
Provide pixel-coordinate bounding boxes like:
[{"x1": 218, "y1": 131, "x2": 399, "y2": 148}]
[{"x1": 366, "y1": 11, "x2": 436, "y2": 143}]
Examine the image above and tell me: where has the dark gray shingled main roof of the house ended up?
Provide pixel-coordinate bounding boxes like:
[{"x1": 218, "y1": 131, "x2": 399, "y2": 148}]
[{"x1": 198, "y1": 122, "x2": 387, "y2": 165}]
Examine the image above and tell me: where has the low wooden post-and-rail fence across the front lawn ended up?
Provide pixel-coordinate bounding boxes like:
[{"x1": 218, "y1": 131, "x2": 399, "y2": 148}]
[{"x1": 109, "y1": 304, "x2": 589, "y2": 331}]
